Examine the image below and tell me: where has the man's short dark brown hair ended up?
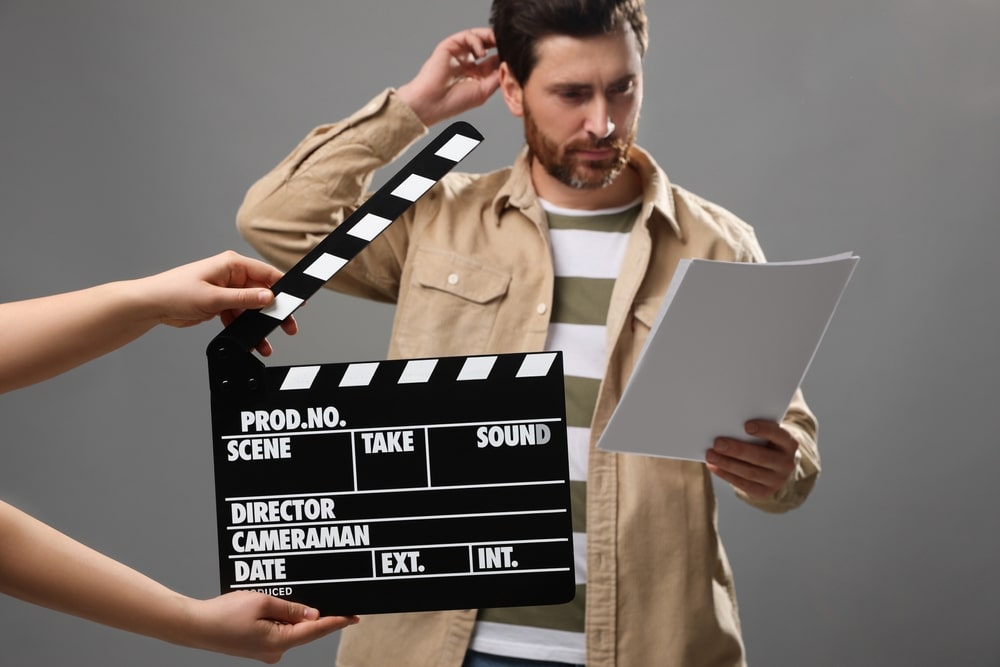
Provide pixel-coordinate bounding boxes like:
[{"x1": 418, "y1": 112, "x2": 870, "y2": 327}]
[{"x1": 490, "y1": 0, "x2": 648, "y2": 85}]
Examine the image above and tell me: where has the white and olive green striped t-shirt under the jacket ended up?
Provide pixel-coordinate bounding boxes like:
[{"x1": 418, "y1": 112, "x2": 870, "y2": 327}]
[{"x1": 471, "y1": 199, "x2": 641, "y2": 664}]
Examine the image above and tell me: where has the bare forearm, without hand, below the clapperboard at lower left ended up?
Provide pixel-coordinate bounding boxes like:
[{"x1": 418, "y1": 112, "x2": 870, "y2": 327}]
[{"x1": 0, "y1": 503, "x2": 191, "y2": 643}]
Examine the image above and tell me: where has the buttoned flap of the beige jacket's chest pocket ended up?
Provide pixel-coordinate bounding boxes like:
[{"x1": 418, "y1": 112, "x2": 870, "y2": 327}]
[{"x1": 413, "y1": 248, "x2": 510, "y2": 303}]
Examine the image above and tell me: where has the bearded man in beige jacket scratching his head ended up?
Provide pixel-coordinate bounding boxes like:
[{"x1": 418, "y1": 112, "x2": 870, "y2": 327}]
[{"x1": 238, "y1": 0, "x2": 819, "y2": 667}]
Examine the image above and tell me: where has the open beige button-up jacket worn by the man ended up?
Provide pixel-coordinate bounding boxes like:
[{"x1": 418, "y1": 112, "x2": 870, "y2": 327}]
[{"x1": 238, "y1": 90, "x2": 819, "y2": 667}]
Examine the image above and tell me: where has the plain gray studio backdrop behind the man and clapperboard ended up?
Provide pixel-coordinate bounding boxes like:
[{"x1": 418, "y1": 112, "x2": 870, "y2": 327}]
[{"x1": 0, "y1": 0, "x2": 1000, "y2": 667}]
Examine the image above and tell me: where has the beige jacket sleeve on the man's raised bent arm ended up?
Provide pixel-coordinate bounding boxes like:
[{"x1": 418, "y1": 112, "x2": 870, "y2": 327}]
[{"x1": 236, "y1": 89, "x2": 427, "y2": 302}]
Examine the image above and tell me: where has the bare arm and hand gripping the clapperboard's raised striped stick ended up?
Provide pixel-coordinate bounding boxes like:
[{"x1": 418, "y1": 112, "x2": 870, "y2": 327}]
[{"x1": 0, "y1": 251, "x2": 296, "y2": 393}]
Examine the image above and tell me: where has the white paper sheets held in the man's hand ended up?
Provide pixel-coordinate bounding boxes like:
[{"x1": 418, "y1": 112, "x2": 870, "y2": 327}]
[{"x1": 598, "y1": 253, "x2": 858, "y2": 461}]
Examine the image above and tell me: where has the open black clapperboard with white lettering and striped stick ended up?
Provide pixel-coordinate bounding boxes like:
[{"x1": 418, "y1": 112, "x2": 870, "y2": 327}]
[{"x1": 207, "y1": 122, "x2": 575, "y2": 615}]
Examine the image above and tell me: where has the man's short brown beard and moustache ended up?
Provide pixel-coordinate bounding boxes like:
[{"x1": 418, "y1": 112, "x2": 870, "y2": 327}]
[{"x1": 524, "y1": 107, "x2": 635, "y2": 190}]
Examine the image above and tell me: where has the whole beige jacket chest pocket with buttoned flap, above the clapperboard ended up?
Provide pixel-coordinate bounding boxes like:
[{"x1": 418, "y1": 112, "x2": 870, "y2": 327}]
[{"x1": 396, "y1": 248, "x2": 511, "y2": 357}]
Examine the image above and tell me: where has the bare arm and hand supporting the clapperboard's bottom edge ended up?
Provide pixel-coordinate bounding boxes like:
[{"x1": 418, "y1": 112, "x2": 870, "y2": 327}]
[{"x1": 0, "y1": 502, "x2": 358, "y2": 662}]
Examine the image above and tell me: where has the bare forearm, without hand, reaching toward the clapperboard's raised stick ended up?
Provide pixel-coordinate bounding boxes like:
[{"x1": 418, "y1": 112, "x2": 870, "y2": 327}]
[{"x1": 0, "y1": 281, "x2": 158, "y2": 393}]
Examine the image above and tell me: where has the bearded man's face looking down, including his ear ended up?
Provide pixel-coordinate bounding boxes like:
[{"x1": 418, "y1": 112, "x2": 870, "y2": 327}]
[{"x1": 502, "y1": 29, "x2": 642, "y2": 189}]
